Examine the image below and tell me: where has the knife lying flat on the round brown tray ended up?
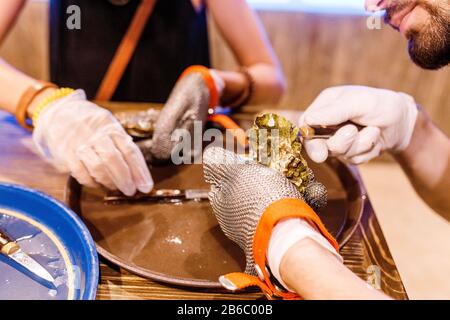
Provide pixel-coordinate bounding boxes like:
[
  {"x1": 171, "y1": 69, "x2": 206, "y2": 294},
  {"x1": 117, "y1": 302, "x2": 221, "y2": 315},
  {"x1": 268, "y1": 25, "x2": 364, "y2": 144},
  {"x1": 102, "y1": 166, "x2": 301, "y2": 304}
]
[{"x1": 103, "y1": 189, "x2": 209, "y2": 204}]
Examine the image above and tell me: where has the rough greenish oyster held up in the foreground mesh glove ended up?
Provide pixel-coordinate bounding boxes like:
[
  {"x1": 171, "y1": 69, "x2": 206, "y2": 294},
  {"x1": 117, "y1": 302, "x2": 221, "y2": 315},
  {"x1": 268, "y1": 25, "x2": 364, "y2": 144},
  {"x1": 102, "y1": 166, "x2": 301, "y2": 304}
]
[{"x1": 249, "y1": 113, "x2": 327, "y2": 210}]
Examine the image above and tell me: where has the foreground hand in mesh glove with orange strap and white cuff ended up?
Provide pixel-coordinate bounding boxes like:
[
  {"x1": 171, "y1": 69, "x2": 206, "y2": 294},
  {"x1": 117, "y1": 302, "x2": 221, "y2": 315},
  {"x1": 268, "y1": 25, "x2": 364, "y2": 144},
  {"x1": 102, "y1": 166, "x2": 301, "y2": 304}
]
[{"x1": 203, "y1": 147, "x2": 339, "y2": 294}]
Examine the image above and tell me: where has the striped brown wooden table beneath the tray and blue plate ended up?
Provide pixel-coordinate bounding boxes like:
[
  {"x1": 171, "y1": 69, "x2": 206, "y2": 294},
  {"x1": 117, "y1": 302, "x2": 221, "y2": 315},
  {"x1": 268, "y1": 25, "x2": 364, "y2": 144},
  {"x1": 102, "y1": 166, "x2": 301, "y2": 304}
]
[{"x1": 0, "y1": 103, "x2": 408, "y2": 299}]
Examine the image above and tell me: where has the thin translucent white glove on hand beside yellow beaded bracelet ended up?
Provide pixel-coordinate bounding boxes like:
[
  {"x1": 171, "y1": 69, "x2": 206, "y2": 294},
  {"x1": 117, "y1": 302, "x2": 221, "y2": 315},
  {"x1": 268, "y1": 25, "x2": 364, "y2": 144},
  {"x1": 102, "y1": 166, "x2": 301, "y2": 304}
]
[{"x1": 33, "y1": 90, "x2": 153, "y2": 196}]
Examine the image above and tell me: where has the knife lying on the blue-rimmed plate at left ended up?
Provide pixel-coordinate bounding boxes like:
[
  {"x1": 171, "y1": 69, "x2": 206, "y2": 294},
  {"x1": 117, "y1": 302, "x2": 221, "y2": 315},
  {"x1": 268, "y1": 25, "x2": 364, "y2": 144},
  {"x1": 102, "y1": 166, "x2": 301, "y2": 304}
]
[{"x1": 0, "y1": 230, "x2": 55, "y2": 283}]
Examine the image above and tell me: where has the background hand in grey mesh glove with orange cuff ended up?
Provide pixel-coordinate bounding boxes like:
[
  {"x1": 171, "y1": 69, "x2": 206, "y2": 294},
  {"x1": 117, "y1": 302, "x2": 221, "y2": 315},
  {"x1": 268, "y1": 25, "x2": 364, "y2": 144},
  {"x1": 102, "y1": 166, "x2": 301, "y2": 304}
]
[{"x1": 138, "y1": 66, "x2": 225, "y2": 162}]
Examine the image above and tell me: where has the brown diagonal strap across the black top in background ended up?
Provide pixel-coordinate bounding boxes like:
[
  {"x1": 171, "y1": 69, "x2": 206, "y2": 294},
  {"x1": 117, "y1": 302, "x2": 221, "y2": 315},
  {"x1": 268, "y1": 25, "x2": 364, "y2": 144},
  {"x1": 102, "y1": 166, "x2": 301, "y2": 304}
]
[{"x1": 95, "y1": 0, "x2": 157, "y2": 101}]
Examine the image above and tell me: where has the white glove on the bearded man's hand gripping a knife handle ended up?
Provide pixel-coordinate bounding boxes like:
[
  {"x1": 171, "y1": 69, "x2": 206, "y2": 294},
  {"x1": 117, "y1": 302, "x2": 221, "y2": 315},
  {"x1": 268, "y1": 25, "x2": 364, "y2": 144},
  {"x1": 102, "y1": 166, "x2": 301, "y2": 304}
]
[{"x1": 299, "y1": 86, "x2": 418, "y2": 164}]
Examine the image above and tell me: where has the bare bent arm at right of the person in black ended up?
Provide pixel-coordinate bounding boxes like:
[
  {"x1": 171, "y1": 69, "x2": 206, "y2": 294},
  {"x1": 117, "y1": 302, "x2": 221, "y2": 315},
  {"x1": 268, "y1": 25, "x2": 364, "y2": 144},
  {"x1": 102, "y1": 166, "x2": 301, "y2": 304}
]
[{"x1": 206, "y1": 0, "x2": 285, "y2": 104}]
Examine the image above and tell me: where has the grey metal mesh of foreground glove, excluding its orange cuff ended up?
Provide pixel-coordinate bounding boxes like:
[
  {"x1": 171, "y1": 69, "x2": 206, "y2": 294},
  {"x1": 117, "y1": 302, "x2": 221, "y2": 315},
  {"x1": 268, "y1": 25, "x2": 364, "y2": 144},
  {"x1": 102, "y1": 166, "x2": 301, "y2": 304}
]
[{"x1": 203, "y1": 147, "x2": 303, "y2": 275}]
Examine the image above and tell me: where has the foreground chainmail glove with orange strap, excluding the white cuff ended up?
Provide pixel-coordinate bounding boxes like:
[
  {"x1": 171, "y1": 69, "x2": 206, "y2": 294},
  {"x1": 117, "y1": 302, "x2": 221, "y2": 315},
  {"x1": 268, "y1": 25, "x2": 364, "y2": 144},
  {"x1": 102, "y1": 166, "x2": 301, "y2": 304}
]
[{"x1": 203, "y1": 147, "x2": 338, "y2": 298}]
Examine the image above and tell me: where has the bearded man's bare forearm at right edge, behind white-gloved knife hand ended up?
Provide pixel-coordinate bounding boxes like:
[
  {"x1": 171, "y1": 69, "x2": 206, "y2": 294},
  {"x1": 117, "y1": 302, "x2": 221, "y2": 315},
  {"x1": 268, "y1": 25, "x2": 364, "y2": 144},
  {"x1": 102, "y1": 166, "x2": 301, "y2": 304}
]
[{"x1": 395, "y1": 110, "x2": 450, "y2": 220}]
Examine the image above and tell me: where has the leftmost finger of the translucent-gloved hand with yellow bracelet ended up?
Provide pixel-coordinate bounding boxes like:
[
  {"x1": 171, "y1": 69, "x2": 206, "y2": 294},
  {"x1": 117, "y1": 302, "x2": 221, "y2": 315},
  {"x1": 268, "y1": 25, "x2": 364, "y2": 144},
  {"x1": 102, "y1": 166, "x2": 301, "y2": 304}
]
[{"x1": 77, "y1": 146, "x2": 117, "y2": 190}]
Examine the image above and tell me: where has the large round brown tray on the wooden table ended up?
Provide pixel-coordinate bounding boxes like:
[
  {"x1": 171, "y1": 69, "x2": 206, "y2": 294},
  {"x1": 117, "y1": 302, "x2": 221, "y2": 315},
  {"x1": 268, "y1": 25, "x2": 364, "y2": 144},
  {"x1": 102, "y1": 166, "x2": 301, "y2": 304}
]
[{"x1": 65, "y1": 160, "x2": 365, "y2": 289}]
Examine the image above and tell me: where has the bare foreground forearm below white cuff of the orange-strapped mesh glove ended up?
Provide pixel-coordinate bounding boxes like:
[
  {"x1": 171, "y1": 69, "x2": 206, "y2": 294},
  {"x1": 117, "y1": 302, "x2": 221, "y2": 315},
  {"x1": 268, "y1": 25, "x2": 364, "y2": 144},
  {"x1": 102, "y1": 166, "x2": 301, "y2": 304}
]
[{"x1": 280, "y1": 239, "x2": 389, "y2": 300}]
